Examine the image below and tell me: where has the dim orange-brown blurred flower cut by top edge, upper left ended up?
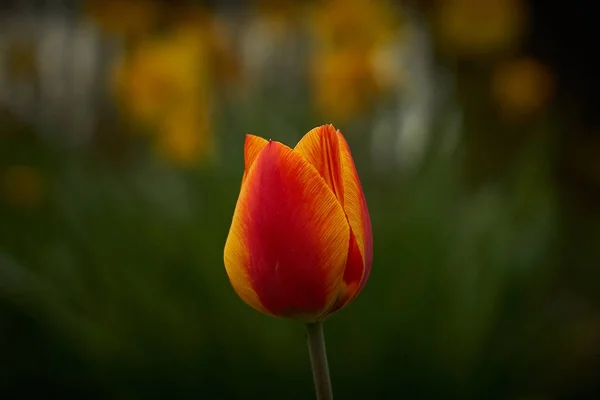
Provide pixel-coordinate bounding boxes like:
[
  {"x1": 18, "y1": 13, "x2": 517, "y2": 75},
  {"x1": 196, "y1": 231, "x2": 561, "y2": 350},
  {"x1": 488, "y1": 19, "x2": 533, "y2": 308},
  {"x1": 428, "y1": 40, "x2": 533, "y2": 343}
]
[{"x1": 84, "y1": 0, "x2": 162, "y2": 38}]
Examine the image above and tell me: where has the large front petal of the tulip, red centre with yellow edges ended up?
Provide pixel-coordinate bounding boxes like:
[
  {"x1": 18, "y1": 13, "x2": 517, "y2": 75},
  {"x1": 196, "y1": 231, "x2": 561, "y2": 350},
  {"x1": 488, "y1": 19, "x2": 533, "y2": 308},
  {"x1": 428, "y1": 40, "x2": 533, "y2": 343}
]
[{"x1": 224, "y1": 142, "x2": 350, "y2": 322}]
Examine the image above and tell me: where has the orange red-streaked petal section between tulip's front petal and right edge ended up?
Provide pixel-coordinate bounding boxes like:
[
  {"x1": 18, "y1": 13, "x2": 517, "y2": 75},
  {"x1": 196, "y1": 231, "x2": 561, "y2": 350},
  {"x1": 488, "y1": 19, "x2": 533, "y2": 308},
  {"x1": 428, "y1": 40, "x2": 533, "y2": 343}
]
[{"x1": 294, "y1": 124, "x2": 344, "y2": 205}]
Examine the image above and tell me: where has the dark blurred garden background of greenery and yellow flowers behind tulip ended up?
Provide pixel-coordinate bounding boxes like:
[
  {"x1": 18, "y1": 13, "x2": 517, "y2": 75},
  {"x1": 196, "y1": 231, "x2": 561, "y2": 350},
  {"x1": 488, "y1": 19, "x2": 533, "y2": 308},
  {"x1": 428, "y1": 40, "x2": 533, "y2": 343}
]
[{"x1": 0, "y1": 0, "x2": 600, "y2": 400}]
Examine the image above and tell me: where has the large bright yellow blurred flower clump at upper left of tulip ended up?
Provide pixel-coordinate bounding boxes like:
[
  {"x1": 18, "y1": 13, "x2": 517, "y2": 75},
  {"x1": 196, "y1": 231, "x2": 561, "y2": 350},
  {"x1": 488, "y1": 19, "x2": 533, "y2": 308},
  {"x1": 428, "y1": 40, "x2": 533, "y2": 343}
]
[{"x1": 112, "y1": 16, "x2": 219, "y2": 165}]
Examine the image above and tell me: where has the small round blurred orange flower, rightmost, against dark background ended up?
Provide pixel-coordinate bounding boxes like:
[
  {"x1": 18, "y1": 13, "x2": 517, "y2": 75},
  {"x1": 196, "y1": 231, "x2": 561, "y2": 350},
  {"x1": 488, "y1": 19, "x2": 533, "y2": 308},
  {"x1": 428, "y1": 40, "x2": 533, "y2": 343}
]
[{"x1": 492, "y1": 58, "x2": 554, "y2": 122}]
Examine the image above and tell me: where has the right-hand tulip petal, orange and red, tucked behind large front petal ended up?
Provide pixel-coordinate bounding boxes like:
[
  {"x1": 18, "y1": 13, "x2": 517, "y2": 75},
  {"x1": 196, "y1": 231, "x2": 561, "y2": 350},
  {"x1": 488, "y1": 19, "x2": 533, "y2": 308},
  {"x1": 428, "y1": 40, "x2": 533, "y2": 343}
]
[{"x1": 294, "y1": 124, "x2": 373, "y2": 306}]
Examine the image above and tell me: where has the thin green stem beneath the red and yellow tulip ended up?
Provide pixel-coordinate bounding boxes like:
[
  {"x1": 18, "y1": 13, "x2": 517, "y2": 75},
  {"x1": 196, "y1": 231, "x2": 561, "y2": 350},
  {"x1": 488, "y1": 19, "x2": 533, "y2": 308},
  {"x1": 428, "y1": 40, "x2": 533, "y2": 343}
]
[{"x1": 306, "y1": 322, "x2": 333, "y2": 400}]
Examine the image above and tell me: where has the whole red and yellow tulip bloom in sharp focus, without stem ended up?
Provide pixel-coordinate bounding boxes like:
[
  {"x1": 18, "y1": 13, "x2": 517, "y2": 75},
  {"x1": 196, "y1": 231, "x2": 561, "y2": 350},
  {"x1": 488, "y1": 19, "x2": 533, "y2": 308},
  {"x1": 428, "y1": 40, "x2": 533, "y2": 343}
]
[{"x1": 224, "y1": 125, "x2": 373, "y2": 323}]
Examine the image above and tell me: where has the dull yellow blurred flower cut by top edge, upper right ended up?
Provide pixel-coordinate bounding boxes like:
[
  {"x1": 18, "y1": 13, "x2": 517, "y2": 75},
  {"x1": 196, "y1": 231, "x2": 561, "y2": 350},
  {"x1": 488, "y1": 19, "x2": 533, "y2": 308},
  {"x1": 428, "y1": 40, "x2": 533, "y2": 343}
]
[{"x1": 434, "y1": 0, "x2": 527, "y2": 57}]
